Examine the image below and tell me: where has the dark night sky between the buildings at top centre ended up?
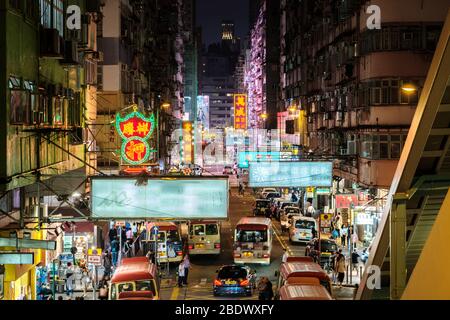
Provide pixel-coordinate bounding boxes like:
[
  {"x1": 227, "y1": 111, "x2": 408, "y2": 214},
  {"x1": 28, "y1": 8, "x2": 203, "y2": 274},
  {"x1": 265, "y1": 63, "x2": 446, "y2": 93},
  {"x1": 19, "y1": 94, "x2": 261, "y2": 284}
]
[{"x1": 197, "y1": 0, "x2": 251, "y2": 46}]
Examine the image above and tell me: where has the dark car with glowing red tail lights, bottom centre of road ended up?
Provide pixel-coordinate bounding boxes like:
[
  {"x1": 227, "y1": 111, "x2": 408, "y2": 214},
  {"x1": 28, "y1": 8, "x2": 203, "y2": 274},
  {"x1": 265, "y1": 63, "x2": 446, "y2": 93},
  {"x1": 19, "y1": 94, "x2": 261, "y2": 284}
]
[{"x1": 213, "y1": 265, "x2": 256, "y2": 296}]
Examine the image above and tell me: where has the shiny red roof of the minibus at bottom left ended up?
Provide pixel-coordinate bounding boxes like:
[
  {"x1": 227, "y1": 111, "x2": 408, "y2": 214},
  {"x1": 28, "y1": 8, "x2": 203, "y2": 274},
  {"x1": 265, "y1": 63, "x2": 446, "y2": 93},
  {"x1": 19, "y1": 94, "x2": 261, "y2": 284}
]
[{"x1": 111, "y1": 258, "x2": 156, "y2": 283}]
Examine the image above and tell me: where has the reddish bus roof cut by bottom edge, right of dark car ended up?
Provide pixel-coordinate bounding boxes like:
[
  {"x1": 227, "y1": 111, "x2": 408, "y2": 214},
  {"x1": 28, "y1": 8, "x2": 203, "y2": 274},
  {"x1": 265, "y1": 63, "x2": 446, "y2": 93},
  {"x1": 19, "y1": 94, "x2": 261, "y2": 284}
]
[{"x1": 279, "y1": 284, "x2": 333, "y2": 300}]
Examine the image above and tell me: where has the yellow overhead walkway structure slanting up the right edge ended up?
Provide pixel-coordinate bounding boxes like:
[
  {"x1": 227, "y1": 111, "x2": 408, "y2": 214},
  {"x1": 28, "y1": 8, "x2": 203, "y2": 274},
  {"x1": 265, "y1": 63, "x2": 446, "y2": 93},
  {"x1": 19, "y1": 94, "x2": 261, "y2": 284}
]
[{"x1": 356, "y1": 11, "x2": 450, "y2": 299}]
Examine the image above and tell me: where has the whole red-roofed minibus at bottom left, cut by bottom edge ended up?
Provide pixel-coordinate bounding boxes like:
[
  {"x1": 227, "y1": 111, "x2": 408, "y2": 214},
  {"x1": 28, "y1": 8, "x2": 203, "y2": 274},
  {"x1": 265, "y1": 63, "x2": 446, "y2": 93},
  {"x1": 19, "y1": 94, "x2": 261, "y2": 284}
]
[{"x1": 109, "y1": 257, "x2": 160, "y2": 300}]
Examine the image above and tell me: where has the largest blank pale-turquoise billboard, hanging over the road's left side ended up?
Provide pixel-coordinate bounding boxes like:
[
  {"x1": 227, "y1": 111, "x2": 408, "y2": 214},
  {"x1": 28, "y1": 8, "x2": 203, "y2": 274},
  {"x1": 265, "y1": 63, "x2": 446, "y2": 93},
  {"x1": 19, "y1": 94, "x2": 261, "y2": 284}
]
[{"x1": 91, "y1": 177, "x2": 228, "y2": 220}]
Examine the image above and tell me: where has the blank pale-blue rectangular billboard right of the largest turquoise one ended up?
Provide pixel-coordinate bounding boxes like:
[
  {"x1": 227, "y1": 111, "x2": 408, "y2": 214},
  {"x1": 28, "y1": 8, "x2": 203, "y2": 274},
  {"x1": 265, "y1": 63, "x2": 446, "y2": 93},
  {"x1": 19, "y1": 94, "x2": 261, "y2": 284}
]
[{"x1": 249, "y1": 162, "x2": 333, "y2": 188}]
